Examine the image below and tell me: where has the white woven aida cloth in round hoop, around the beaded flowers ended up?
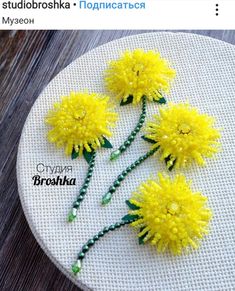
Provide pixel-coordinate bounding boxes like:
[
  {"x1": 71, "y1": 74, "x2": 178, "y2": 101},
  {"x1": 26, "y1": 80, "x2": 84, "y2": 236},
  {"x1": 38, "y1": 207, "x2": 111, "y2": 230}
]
[{"x1": 17, "y1": 33, "x2": 235, "y2": 291}]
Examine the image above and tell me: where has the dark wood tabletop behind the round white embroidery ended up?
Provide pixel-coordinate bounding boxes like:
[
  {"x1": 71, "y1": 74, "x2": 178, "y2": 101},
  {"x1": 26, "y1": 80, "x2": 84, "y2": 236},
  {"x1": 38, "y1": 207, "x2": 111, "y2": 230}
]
[{"x1": 0, "y1": 30, "x2": 235, "y2": 291}]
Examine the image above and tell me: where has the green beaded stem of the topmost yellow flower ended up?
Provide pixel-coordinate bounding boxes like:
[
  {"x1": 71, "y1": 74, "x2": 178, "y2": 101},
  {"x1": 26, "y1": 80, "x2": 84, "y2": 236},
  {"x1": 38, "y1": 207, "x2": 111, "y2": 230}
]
[{"x1": 110, "y1": 96, "x2": 146, "y2": 161}]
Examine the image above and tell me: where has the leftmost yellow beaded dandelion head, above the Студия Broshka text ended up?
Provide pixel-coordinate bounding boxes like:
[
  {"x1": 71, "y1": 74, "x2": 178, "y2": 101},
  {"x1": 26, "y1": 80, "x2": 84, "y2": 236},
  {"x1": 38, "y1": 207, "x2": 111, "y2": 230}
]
[{"x1": 46, "y1": 92, "x2": 117, "y2": 155}]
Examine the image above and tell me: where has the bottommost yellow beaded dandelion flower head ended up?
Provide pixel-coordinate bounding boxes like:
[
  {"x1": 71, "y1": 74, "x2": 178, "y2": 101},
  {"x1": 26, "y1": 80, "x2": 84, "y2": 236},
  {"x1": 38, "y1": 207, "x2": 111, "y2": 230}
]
[{"x1": 129, "y1": 174, "x2": 212, "y2": 255}]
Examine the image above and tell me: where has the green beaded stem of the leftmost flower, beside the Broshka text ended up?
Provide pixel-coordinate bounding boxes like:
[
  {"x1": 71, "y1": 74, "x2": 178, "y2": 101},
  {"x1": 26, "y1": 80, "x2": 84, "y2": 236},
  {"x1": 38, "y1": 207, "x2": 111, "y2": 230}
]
[{"x1": 68, "y1": 152, "x2": 96, "y2": 222}]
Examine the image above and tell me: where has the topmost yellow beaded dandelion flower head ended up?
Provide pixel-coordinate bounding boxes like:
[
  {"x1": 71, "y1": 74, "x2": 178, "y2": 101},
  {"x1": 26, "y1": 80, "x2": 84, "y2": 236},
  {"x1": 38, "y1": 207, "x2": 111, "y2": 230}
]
[{"x1": 105, "y1": 49, "x2": 175, "y2": 104}]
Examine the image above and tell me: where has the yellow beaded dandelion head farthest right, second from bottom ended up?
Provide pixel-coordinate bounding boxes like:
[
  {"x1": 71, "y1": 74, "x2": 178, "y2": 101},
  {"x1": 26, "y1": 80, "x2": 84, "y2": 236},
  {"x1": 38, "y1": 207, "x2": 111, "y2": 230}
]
[{"x1": 145, "y1": 104, "x2": 220, "y2": 168}]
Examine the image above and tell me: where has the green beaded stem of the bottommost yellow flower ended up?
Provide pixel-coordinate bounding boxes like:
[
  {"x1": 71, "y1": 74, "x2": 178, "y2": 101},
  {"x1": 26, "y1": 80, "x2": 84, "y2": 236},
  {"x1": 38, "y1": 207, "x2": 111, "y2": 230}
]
[{"x1": 72, "y1": 218, "x2": 137, "y2": 275}]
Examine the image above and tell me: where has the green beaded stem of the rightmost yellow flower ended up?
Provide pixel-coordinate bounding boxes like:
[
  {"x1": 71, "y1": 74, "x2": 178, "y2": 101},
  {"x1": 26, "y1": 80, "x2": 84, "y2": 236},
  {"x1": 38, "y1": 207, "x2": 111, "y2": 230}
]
[{"x1": 101, "y1": 147, "x2": 159, "y2": 205}]
